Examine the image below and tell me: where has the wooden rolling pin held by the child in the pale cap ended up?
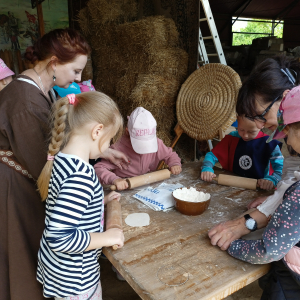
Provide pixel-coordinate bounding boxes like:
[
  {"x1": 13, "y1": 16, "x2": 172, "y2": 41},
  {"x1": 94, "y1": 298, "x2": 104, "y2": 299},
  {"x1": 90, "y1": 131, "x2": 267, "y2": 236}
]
[{"x1": 110, "y1": 169, "x2": 171, "y2": 191}]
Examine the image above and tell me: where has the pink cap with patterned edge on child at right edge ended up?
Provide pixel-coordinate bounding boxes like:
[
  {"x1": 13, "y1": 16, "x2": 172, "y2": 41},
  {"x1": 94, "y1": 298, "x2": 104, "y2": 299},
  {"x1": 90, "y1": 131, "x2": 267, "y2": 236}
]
[{"x1": 267, "y1": 86, "x2": 300, "y2": 142}]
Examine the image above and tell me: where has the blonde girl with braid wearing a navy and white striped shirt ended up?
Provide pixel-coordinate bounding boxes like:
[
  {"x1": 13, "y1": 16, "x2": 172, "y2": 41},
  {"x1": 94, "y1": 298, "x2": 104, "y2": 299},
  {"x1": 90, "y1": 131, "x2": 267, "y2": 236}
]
[{"x1": 37, "y1": 92, "x2": 124, "y2": 300}]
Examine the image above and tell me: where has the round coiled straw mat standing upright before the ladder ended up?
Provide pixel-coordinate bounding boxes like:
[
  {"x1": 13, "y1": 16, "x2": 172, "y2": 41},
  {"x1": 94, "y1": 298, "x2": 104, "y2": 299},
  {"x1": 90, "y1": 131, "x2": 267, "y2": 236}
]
[{"x1": 176, "y1": 64, "x2": 242, "y2": 141}]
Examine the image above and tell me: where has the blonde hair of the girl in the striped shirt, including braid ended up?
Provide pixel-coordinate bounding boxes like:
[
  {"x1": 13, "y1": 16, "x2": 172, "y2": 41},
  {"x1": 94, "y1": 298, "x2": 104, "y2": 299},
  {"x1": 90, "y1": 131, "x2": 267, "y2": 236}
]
[{"x1": 37, "y1": 92, "x2": 123, "y2": 201}]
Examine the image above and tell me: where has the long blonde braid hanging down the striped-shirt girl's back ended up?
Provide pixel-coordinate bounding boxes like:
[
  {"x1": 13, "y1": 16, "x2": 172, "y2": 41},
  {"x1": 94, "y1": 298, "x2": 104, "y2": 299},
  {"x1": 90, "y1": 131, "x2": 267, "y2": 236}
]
[{"x1": 37, "y1": 97, "x2": 69, "y2": 201}]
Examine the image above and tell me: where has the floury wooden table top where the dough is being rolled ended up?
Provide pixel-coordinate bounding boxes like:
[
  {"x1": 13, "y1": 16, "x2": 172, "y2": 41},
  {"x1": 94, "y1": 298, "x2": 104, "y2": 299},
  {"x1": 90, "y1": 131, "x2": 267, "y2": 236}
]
[{"x1": 103, "y1": 163, "x2": 269, "y2": 300}]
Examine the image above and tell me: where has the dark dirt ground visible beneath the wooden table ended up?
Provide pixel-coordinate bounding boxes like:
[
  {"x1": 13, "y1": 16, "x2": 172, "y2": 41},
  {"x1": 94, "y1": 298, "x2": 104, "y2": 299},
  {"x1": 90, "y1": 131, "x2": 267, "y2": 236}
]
[{"x1": 100, "y1": 259, "x2": 262, "y2": 300}]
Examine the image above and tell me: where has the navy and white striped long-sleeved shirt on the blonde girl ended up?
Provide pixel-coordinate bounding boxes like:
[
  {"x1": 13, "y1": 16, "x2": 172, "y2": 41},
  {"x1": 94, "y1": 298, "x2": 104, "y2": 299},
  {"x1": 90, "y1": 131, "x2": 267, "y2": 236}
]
[{"x1": 37, "y1": 152, "x2": 104, "y2": 298}]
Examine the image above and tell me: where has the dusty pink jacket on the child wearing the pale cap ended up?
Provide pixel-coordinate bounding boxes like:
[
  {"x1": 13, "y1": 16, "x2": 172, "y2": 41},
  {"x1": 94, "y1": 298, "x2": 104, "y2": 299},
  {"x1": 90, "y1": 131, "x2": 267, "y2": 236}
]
[{"x1": 94, "y1": 134, "x2": 181, "y2": 184}]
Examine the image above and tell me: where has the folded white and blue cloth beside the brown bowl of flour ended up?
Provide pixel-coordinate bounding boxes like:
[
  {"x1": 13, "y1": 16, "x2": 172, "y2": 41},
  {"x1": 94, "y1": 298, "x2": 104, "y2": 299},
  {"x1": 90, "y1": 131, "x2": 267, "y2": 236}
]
[{"x1": 133, "y1": 182, "x2": 184, "y2": 211}]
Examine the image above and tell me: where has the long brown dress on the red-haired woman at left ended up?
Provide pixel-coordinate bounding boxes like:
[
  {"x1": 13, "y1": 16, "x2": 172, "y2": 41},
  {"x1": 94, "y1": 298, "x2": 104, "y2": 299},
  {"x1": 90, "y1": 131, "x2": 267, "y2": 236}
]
[{"x1": 0, "y1": 75, "x2": 54, "y2": 300}]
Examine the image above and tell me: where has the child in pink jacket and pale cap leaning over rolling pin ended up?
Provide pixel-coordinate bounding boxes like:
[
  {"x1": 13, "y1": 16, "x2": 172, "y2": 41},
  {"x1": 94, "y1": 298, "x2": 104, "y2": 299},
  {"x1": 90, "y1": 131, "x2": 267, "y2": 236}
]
[{"x1": 94, "y1": 107, "x2": 181, "y2": 190}]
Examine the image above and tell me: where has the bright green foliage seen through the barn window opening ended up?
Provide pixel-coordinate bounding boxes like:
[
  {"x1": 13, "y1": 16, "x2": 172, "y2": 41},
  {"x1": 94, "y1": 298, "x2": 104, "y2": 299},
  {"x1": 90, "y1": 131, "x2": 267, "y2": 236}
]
[{"x1": 232, "y1": 20, "x2": 283, "y2": 46}]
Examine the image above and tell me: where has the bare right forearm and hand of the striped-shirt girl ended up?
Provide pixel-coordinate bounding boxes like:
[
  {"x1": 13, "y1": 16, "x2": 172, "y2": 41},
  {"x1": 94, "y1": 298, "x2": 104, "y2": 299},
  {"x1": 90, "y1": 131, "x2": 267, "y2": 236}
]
[{"x1": 85, "y1": 228, "x2": 124, "y2": 251}]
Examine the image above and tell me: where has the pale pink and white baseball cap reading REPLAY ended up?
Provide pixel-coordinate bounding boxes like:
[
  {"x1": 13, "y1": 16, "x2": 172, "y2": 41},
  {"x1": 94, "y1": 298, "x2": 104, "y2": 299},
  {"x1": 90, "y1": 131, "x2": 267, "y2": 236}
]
[{"x1": 127, "y1": 107, "x2": 158, "y2": 154}]
